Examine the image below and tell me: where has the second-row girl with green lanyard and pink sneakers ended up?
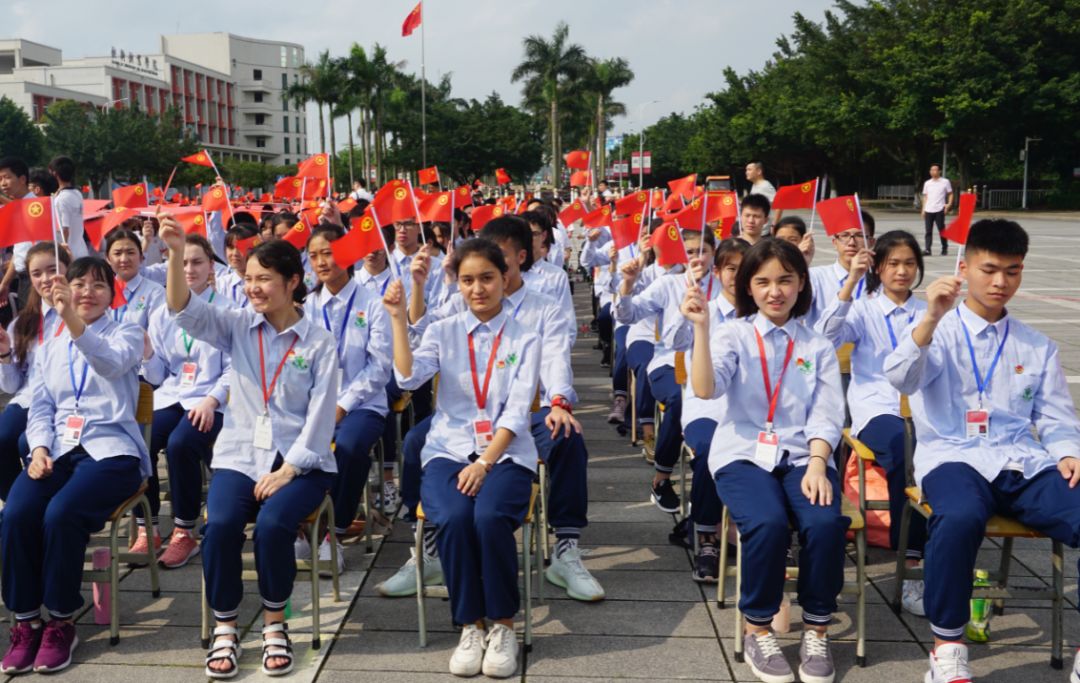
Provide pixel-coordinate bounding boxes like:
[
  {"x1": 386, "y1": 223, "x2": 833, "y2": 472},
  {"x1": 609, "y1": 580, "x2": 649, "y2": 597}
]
[{"x1": 136, "y1": 235, "x2": 231, "y2": 570}]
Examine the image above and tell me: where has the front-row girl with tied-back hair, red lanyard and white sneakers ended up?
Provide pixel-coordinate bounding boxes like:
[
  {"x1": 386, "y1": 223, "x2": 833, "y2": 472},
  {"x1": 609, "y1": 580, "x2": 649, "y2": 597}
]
[{"x1": 383, "y1": 239, "x2": 540, "y2": 678}]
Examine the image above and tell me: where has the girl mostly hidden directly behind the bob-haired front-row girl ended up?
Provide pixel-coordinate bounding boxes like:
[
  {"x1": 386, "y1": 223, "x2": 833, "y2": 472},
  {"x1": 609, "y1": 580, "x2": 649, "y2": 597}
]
[{"x1": 670, "y1": 238, "x2": 750, "y2": 584}]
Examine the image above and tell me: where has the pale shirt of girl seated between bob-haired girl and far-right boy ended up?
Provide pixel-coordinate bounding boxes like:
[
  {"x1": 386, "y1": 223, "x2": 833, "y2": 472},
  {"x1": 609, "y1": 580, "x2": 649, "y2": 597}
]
[{"x1": 814, "y1": 293, "x2": 927, "y2": 434}]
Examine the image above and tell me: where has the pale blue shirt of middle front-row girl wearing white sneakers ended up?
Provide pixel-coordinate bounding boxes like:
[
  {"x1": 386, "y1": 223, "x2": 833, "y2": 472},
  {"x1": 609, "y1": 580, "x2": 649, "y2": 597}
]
[{"x1": 394, "y1": 309, "x2": 540, "y2": 472}]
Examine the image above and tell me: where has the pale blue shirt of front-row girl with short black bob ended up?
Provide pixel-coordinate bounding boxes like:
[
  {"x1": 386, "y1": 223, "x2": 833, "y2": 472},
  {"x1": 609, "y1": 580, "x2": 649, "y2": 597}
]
[{"x1": 704, "y1": 314, "x2": 843, "y2": 474}]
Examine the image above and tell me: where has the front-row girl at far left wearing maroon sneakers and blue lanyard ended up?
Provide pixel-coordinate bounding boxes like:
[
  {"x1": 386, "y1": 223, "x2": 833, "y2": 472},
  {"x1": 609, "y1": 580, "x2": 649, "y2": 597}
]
[{"x1": 0, "y1": 256, "x2": 150, "y2": 674}]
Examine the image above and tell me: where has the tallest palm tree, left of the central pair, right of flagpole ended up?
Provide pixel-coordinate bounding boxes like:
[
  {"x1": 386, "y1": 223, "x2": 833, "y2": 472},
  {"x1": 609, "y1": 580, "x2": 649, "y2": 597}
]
[{"x1": 511, "y1": 22, "x2": 589, "y2": 186}]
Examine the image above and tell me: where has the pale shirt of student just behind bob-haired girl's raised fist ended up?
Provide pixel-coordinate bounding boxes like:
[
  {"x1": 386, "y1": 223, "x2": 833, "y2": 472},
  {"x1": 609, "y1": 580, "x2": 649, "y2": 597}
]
[{"x1": 615, "y1": 271, "x2": 724, "y2": 374}]
